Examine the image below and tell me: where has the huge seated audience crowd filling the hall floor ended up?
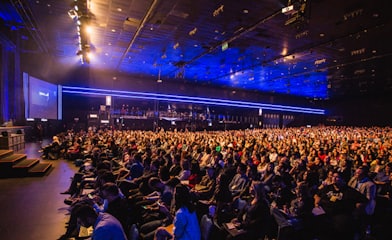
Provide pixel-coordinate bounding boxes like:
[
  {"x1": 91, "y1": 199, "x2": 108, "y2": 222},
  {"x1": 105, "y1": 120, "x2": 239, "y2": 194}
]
[{"x1": 56, "y1": 127, "x2": 392, "y2": 240}]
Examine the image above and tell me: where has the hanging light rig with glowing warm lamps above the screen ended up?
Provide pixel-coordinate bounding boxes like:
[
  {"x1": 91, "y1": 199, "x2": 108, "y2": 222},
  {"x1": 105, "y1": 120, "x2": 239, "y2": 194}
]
[{"x1": 68, "y1": 0, "x2": 91, "y2": 64}]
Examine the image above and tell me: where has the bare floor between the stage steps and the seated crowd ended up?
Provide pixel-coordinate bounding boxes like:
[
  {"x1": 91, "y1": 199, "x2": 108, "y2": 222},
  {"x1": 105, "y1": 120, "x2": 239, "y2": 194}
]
[{"x1": 0, "y1": 141, "x2": 77, "y2": 240}]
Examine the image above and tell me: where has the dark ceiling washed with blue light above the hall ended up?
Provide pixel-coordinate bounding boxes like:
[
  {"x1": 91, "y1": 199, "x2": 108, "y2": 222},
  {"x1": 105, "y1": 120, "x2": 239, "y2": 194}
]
[{"x1": 0, "y1": 0, "x2": 392, "y2": 99}]
